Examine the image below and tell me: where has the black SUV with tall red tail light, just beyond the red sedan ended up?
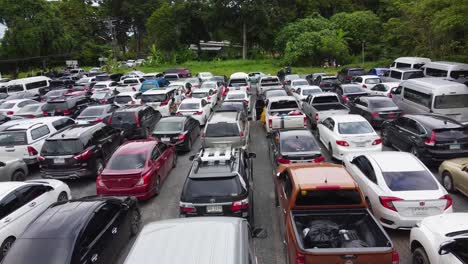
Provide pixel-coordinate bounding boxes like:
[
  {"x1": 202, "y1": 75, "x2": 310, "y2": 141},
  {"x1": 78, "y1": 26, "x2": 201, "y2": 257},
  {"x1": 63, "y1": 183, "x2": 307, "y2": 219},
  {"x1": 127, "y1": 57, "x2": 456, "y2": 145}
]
[{"x1": 107, "y1": 105, "x2": 161, "y2": 139}]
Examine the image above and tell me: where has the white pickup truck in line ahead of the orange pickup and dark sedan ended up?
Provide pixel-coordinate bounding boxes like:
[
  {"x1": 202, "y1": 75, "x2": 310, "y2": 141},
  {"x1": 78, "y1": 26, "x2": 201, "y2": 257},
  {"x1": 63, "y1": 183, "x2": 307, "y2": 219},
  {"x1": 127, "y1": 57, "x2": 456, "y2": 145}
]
[{"x1": 265, "y1": 96, "x2": 307, "y2": 133}]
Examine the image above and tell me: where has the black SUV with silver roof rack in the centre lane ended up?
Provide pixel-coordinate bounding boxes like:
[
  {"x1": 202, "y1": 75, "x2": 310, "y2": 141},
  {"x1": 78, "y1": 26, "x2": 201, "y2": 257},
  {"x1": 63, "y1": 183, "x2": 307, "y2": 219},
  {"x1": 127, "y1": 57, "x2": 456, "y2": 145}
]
[{"x1": 180, "y1": 148, "x2": 256, "y2": 226}]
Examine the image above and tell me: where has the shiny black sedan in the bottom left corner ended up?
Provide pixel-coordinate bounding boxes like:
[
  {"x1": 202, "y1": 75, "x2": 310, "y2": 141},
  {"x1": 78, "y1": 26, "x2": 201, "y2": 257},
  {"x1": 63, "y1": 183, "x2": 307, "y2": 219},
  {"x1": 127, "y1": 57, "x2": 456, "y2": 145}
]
[{"x1": 2, "y1": 197, "x2": 141, "y2": 264}]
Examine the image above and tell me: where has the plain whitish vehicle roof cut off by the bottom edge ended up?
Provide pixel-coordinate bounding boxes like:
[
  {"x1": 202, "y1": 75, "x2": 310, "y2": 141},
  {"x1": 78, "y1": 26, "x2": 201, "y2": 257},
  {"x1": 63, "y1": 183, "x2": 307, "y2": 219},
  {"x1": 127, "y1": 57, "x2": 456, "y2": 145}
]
[{"x1": 124, "y1": 216, "x2": 248, "y2": 264}]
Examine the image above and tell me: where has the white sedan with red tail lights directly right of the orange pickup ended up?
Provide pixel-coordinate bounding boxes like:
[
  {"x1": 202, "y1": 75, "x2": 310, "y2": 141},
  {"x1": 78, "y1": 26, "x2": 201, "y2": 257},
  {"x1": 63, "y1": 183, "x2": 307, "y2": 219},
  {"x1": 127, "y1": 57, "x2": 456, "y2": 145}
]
[{"x1": 343, "y1": 151, "x2": 453, "y2": 229}]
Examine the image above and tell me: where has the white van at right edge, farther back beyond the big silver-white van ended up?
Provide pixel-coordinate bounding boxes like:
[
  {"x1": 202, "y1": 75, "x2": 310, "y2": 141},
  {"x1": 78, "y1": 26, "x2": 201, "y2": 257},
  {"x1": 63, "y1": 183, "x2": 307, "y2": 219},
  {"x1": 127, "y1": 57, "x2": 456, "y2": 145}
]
[{"x1": 421, "y1": 61, "x2": 468, "y2": 79}]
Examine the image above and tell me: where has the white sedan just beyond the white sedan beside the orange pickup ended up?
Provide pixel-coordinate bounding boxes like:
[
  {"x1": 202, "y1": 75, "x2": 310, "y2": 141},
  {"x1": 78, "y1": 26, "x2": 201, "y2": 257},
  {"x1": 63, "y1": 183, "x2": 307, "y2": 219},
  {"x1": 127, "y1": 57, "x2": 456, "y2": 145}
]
[{"x1": 317, "y1": 115, "x2": 382, "y2": 160}]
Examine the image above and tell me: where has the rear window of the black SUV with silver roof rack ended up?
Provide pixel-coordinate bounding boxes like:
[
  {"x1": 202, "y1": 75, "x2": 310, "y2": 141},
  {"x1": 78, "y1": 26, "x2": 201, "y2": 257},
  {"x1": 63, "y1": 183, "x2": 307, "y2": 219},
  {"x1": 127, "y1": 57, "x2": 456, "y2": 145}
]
[{"x1": 183, "y1": 176, "x2": 243, "y2": 199}]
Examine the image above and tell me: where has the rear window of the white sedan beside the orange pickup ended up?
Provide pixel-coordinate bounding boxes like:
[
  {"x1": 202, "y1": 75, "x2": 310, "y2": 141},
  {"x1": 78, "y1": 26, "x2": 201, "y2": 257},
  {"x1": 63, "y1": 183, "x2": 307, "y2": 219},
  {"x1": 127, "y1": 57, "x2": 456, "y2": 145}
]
[{"x1": 382, "y1": 171, "x2": 439, "y2": 191}]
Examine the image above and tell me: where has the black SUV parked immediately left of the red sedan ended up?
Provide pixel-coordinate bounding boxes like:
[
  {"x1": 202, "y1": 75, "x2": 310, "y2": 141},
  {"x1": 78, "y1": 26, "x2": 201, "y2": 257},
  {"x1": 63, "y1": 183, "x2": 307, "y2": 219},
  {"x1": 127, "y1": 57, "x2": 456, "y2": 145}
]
[{"x1": 38, "y1": 123, "x2": 122, "y2": 179}]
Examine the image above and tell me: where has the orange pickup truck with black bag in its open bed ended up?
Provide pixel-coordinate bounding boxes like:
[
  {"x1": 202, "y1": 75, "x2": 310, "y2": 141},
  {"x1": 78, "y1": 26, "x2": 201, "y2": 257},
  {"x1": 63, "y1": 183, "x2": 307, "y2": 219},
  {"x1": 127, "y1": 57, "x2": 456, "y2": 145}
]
[{"x1": 274, "y1": 163, "x2": 399, "y2": 264}]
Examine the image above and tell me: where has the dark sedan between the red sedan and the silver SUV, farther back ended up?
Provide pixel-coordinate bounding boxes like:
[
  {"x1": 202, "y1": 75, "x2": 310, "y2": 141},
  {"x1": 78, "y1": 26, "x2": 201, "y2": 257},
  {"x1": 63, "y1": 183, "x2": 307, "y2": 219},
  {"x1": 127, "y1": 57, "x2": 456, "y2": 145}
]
[{"x1": 152, "y1": 116, "x2": 200, "y2": 151}]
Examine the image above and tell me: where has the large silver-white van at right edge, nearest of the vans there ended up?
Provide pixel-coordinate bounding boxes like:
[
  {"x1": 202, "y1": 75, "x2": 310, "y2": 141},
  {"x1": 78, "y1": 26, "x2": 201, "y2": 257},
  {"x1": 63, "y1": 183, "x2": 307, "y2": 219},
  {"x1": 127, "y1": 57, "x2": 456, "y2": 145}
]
[{"x1": 391, "y1": 78, "x2": 468, "y2": 123}]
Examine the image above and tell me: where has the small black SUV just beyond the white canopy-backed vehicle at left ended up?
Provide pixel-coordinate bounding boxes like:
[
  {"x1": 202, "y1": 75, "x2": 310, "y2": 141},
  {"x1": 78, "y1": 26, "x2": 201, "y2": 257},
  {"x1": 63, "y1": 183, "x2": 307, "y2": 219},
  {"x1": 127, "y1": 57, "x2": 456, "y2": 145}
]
[{"x1": 42, "y1": 96, "x2": 91, "y2": 118}]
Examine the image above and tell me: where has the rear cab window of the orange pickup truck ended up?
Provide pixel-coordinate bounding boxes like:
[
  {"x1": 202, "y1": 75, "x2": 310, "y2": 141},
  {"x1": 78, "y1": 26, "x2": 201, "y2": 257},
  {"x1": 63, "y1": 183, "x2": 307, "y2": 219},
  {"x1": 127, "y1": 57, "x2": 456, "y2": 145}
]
[{"x1": 296, "y1": 189, "x2": 362, "y2": 206}]
